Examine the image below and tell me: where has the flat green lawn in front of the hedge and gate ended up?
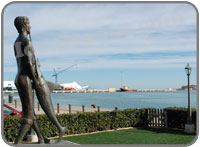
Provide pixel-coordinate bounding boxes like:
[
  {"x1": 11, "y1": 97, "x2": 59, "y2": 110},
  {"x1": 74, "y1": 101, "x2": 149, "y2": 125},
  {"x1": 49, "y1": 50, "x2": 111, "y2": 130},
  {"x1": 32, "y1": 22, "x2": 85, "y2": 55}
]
[{"x1": 63, "y1": 128, "x2": 195, "y2": 144}]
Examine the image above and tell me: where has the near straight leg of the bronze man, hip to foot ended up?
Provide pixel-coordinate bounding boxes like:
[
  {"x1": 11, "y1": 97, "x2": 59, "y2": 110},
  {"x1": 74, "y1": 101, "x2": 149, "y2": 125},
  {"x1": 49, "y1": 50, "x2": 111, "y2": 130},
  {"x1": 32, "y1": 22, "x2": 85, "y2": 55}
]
[{"x1": 15, "y1": 75, "x2": 35, "y2": 144}]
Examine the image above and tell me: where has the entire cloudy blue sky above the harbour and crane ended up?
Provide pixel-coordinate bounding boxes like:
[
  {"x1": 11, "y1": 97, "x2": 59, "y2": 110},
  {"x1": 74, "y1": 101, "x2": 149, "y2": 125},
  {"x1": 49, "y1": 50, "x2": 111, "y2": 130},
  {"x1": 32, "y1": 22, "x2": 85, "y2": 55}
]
[{"x1": 3, "y1": 3, "x2": 197, "y2": 89}]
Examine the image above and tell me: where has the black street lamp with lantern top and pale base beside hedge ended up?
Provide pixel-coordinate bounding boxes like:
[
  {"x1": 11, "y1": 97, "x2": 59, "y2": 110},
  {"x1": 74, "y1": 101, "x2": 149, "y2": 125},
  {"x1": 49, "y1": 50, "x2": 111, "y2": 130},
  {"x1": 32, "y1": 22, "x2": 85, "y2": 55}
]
[{"x1": 185, "y1": 63, "x2": 194, "y2": 132}]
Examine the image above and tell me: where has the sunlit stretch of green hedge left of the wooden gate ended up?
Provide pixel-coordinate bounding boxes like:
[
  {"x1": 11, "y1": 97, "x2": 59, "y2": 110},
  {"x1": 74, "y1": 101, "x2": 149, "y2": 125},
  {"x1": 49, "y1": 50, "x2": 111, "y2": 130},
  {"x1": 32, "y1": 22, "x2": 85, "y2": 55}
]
[{"x1": 4, "y1": 109, "x2": 142, "y2": 142}]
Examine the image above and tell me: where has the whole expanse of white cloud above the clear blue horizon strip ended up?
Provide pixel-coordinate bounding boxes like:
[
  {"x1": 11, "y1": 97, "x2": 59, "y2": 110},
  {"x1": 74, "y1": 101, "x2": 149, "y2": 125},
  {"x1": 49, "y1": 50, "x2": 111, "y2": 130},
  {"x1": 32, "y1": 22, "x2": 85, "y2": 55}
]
[{"x1": 4, "y1": 4, "x2": 196, "y2": 71}]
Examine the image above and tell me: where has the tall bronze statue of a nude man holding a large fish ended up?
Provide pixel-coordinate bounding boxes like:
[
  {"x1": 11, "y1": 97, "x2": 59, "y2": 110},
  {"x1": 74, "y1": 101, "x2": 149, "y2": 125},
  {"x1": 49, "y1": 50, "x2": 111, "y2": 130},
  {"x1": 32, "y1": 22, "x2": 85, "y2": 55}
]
[{"x1": 14, "y1": 16, "x2": 67, "y2": 144}]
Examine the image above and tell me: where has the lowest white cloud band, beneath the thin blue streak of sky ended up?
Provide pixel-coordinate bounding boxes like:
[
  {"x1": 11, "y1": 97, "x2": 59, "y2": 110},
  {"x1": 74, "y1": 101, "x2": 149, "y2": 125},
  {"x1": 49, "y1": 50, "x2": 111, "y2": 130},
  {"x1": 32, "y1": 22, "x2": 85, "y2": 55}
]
[{"x1": 21, "y1": 56, "x2": 196, "y2": 71}]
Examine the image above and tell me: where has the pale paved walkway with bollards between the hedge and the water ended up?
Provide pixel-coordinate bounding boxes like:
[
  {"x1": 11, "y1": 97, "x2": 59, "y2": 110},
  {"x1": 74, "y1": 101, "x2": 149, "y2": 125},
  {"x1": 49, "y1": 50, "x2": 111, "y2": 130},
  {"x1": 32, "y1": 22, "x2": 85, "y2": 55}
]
[{"x1": 5, "y1": 102, "x2": 112, "y2": 114}]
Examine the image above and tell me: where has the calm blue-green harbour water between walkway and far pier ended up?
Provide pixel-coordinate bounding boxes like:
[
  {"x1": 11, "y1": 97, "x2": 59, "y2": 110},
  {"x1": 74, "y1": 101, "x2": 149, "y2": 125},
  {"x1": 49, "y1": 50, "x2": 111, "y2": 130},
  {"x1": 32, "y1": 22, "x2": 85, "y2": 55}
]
[{"x1": 4, "y1": 90, "x2": 197, "y2": 110}]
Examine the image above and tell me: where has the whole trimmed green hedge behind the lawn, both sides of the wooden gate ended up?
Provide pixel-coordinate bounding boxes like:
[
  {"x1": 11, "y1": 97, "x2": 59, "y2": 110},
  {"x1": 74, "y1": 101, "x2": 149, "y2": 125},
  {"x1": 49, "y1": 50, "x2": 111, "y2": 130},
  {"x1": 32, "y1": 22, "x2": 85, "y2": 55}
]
[{"x1": 4, "y1": 108, "x2": 196, "y2": 142}]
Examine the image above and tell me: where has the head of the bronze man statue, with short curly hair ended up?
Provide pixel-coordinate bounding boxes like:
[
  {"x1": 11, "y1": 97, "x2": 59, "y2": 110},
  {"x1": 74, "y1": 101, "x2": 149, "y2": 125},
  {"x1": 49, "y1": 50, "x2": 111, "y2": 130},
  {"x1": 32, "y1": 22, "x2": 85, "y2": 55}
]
[{"x1": 14, "y1": 16, "x2": 31, "y2": 34}]
